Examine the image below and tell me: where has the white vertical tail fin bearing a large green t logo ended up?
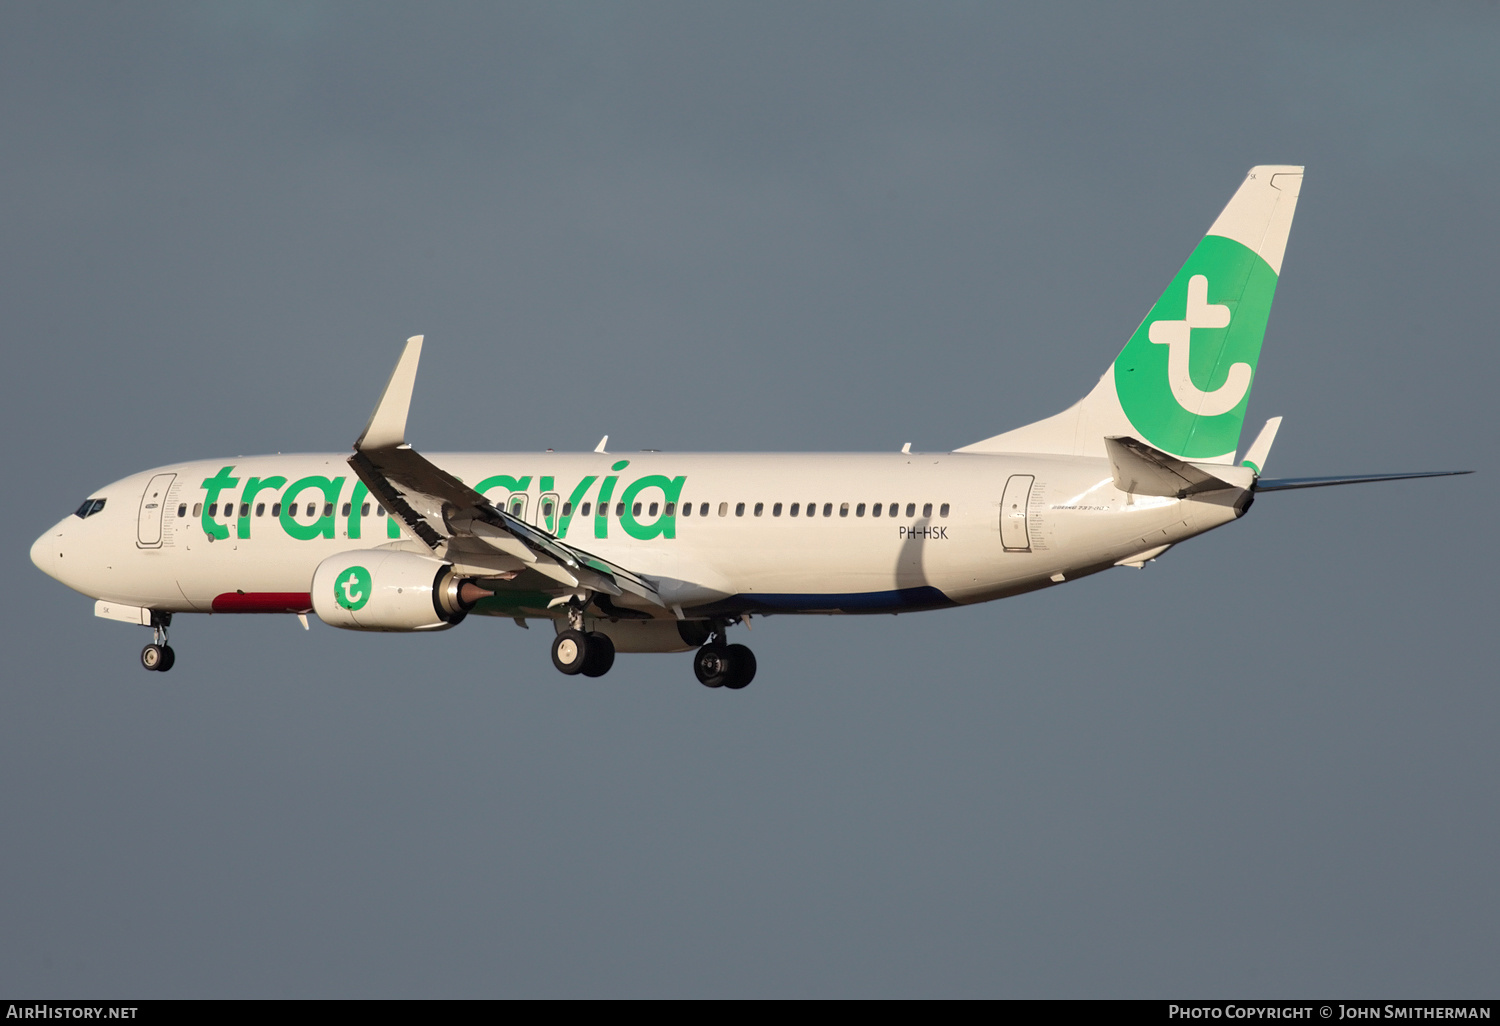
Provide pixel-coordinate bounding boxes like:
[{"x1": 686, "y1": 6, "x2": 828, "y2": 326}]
[{"x1": 957, "y1": 165, "x2": 1302, "y2": 464}]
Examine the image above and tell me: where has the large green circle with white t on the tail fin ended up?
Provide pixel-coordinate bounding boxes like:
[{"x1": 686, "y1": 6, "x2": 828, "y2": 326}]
[{"x1": 1115, "y1": 236, "x2": 1277, "y2": 459}]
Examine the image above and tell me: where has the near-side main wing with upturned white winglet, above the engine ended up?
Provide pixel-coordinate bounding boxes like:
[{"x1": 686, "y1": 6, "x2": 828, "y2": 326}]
[{"x1": 350, "y1": 335, "x2": 666, "y2": 609}]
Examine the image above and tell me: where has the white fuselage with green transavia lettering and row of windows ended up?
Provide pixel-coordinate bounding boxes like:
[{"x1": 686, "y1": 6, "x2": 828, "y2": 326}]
[{"x1": 32, "y1": 453, "x2": 1250, "y2": 617}]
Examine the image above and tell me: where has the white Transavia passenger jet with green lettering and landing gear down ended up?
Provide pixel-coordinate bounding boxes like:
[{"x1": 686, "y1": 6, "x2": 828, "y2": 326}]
[{"x1": 32, "y1": 165, "x2": 1470, "y2": 690}]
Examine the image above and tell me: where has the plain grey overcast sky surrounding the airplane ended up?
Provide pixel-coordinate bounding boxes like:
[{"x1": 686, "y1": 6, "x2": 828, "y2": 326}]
[{"x1": 0, "y1": 2, "x2": 1500, "y2": 998}]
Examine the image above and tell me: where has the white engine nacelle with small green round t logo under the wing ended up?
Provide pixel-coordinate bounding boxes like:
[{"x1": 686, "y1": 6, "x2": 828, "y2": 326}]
[{"x1": 312, "y1": 549, "x2": 489, "y2": 630}]
